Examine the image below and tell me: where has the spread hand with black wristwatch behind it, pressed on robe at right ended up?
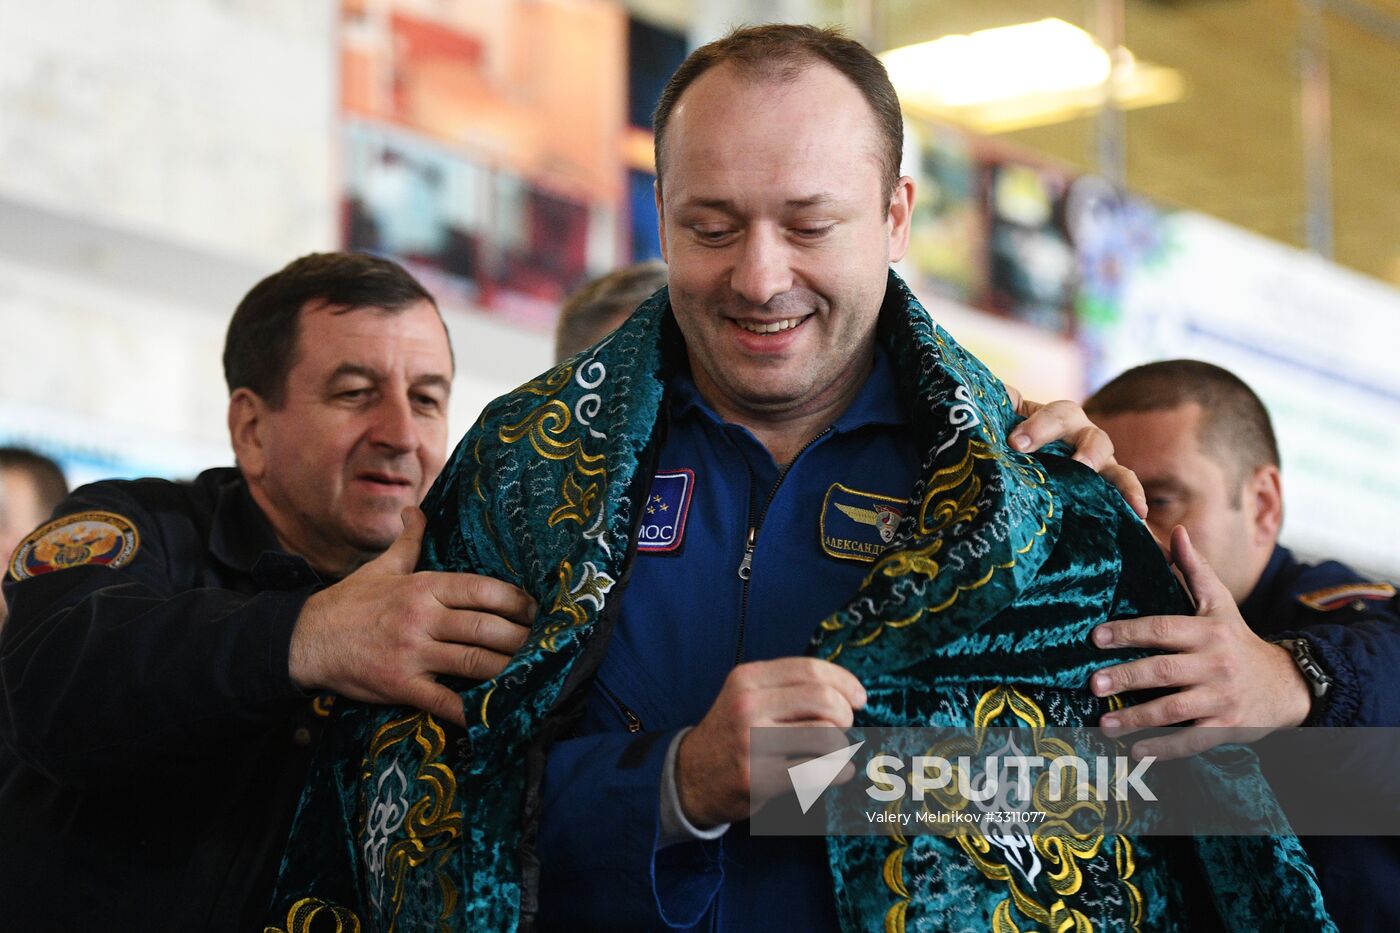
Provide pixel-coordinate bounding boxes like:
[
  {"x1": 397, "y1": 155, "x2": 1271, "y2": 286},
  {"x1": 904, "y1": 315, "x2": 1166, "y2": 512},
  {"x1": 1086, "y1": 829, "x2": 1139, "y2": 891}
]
[{"x1": 1089, "y1": 525, "x2": 1312, "y2": 758}]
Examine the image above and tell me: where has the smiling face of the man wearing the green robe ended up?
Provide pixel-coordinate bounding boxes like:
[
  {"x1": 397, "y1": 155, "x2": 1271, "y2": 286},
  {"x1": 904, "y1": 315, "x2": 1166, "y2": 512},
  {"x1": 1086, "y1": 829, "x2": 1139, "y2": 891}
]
[{"x1": 657, "y1": 63, "x2": 913, "y2": 427}]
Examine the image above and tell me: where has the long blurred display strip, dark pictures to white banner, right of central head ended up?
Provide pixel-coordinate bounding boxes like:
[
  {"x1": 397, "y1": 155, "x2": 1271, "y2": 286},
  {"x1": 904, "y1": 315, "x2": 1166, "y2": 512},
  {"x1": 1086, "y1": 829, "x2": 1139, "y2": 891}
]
[{"x1": 902, "y1": 112, "x2": 1400, "y2": 579}]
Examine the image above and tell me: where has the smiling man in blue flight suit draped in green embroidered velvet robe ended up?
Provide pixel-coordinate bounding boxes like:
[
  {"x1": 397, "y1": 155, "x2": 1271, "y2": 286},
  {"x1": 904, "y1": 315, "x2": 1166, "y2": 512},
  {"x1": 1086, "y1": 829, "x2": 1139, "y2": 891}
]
[{"x1": 273, "y1": 25, "x2": 1331, "y2": 932}]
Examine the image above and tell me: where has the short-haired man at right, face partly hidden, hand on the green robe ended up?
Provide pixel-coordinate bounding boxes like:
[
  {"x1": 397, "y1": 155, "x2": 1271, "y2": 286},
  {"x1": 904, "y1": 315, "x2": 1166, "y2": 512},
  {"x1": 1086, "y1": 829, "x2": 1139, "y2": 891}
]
[{"x1": 1085, "y1": 360, "x2": 1400, "y2": 930}]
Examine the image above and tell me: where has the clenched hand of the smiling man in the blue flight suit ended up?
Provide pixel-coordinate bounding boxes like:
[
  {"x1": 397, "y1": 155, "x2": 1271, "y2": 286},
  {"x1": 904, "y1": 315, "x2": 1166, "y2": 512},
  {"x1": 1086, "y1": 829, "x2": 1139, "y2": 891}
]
[{"x1": 676, "y1": 657, "x2": 865, "y2": 828}]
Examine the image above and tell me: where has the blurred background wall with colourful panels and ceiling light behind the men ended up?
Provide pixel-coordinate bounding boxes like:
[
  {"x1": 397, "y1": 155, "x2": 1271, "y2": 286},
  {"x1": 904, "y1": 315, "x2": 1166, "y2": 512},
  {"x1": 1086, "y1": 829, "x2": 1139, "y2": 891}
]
[{"x1": 0, "y1": 0, "x2": 1400, "y2": 576}]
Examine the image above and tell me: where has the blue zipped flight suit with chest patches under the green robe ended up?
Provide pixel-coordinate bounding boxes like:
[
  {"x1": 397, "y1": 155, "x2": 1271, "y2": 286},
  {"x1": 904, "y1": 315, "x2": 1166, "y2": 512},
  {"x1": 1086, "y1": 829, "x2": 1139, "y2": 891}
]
[{"x1": 538, "y1": 356, "x2": 918, "y2": 933}]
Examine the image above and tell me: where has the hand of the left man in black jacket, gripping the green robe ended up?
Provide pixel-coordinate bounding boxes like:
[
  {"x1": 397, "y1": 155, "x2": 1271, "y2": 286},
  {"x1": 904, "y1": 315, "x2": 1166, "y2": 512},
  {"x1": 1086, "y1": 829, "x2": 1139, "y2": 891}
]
[{"x1": 287, "y1": 509, "x2": 538, "y2": 726}]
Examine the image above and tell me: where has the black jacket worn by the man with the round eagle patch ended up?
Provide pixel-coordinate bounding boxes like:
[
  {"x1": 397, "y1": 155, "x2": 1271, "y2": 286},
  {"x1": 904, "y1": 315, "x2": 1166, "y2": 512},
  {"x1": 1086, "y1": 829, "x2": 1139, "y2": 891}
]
[{"x1": 0, "y1": 469, "x2": 325, "y2": 932}]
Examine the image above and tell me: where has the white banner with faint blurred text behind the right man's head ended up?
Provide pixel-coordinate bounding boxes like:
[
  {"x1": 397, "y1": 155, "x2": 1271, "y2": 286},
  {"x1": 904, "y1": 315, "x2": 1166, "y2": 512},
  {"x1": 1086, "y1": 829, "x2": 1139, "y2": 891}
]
[{"x1": 1086, "y1": 213, "x2": 1400, "y2": 579}]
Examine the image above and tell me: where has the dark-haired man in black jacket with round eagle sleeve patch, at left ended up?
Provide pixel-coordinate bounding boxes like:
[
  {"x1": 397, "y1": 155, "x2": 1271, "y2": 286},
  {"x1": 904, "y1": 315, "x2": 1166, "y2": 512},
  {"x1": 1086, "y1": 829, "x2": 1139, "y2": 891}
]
[{"x1": 0, "y1": 254, "x2": 535, "y2": 930}]
